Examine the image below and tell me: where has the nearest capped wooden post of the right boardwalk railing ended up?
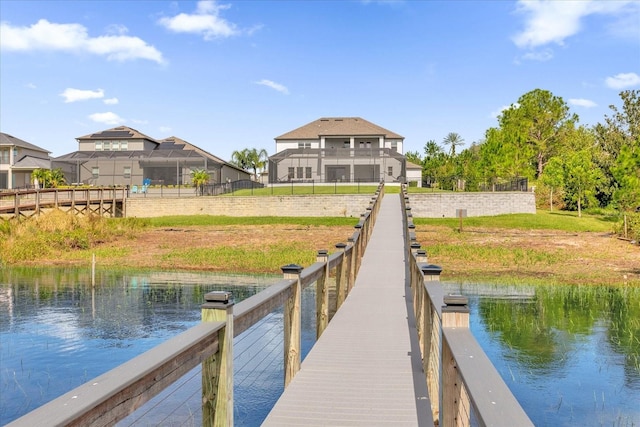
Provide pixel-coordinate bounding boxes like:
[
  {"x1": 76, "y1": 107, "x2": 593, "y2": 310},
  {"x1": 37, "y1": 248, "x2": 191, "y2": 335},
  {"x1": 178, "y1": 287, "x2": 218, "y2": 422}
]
[{"x1": 442, "y1": 295, "x2": 471, "y2": 426}]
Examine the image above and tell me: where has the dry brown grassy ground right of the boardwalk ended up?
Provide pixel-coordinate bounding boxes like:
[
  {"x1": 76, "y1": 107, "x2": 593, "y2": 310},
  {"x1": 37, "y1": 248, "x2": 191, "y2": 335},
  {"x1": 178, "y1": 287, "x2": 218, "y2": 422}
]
[{"x1": 417, "y1": 227, "x2": 640, "y2": 285}]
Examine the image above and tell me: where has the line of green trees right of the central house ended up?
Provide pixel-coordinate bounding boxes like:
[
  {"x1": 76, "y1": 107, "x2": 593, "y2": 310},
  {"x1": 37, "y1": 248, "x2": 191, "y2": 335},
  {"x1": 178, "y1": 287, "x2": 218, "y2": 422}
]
[{"x1": 407, "y1": 89, "x2": 640, "y2": 240}]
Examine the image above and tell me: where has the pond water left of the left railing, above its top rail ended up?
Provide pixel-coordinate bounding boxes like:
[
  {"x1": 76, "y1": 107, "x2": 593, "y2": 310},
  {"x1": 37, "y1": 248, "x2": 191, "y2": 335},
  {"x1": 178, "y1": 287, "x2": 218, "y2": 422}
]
[{"x1": 0, "y1": 269, "x2": 278, "y2": 425}]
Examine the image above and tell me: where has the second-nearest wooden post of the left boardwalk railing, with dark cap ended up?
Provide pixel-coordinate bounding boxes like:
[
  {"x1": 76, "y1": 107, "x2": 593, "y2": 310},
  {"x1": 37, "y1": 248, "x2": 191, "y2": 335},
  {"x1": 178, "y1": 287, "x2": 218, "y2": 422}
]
[{"x1": 281, "y1": 264, "x2": 302, "y2": 387}]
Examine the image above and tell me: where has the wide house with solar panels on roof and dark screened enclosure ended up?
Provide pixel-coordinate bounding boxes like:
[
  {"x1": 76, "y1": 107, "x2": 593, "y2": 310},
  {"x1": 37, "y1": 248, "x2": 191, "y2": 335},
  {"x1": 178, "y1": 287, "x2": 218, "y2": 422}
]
[{"x1": 52, "y1": 126, "x2": 250, "y2": 186}]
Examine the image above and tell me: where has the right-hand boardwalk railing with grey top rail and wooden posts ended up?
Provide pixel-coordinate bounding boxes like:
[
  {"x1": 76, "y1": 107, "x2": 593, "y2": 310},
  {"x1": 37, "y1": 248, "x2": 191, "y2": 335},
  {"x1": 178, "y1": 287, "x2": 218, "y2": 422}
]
[{"x1": 400, "y1": 187, "x2": 533, "y2": 427}]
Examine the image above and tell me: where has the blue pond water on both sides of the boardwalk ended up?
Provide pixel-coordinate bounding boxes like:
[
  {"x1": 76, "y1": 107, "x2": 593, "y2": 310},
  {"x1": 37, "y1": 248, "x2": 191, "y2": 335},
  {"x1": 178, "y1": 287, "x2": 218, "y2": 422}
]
[{"x1": 0, "y1": 269, "x2": 640, "y2": 426}]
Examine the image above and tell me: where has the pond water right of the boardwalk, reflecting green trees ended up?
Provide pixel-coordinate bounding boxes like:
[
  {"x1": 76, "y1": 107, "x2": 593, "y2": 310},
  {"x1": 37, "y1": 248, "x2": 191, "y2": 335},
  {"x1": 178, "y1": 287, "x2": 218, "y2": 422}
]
[{"x1": 448, "y1": 285, "x2": 640, "y2": 426}]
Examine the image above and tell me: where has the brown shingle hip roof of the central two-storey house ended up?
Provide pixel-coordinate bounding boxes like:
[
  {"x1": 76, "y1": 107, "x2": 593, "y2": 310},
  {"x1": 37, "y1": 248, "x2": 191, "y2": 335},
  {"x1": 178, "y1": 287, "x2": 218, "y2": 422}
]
[{"x1": 275, "y1": 117, "x2": 404, "y2": 140}]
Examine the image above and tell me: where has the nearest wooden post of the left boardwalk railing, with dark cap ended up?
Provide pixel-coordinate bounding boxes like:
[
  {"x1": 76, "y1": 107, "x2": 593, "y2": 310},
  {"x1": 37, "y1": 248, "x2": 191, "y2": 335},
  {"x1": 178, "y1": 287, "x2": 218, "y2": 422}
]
[{"x1": 202, "y1": 292, "x2": 234, "y2": 427}]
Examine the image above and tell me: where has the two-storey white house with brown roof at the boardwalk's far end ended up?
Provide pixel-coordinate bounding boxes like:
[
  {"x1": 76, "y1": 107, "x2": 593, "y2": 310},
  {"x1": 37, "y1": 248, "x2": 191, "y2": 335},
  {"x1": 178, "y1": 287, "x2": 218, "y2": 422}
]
[{"x1": 269, "y1": 117, "x2": 407, "y2": 183}]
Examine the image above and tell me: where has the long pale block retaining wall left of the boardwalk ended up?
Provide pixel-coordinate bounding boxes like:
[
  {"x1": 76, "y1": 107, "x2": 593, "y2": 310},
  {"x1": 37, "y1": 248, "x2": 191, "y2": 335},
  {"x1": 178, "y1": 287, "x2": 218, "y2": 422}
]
[{"x1": 126, "y1": 194, "x2": 376, "y2": 218}]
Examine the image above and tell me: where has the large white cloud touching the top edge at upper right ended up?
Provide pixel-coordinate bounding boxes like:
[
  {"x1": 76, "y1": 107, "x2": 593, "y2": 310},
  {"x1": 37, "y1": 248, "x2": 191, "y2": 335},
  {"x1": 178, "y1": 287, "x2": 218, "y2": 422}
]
[{"x1": 513, "y1": 0, "x2": 631, "y2": 48}]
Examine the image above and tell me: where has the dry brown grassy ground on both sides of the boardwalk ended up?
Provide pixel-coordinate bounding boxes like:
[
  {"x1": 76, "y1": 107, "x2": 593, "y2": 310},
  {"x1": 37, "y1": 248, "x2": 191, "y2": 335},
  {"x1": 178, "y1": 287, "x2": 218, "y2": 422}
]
[{"x1": 23, "y1": 225, "x2": 640, "y2": 286}]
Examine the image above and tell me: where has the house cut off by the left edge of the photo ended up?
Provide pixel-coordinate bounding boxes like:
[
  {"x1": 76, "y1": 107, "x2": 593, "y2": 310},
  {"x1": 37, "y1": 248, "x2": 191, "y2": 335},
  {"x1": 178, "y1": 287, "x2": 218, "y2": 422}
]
[{"x1": 0, "y1": 133, "x2": 51, "y2": 190}]
